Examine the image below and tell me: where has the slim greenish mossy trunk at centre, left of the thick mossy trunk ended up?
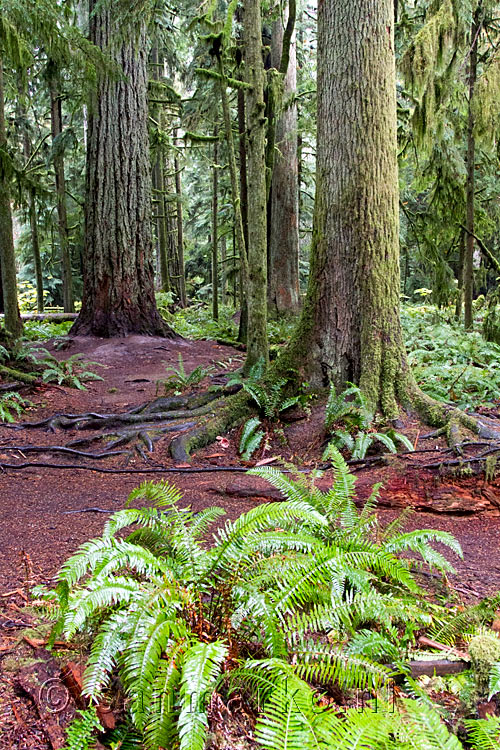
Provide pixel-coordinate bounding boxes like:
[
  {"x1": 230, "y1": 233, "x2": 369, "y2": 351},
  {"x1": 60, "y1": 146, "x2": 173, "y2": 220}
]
[{"x1": 243, "y1": 0, "x2": 269, "y2": 372}]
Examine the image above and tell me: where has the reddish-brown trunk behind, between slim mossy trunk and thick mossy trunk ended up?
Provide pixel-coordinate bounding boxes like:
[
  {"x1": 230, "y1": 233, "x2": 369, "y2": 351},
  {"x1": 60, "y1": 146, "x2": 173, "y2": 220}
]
[{"x1": 268, "y1": 19, "x2": 300, "y2": 315}]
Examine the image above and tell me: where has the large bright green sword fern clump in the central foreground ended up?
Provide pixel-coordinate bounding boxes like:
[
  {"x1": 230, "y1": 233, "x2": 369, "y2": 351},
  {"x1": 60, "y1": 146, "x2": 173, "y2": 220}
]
[{"x1": 48, "y1": 452, "x2": 466, "y2": 750}]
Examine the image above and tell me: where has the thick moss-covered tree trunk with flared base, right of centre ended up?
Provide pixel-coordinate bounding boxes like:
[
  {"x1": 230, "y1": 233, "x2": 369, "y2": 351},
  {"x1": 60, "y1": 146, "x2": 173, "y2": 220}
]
[{"x1": 283, "y1": 0, "x2": 408, "y2": 417}]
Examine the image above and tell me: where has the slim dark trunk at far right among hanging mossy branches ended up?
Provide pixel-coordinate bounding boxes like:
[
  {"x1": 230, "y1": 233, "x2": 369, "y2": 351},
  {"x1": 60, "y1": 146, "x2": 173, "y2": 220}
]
[{"x1": 463, "y1": 2, "x2": 482, "y2": 328}]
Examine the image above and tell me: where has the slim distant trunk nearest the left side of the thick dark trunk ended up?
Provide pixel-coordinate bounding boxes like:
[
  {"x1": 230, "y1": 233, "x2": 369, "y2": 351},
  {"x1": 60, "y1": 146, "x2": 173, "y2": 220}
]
[{"x1": 47, "y1": 60, "x2": 75, "y2": 312}]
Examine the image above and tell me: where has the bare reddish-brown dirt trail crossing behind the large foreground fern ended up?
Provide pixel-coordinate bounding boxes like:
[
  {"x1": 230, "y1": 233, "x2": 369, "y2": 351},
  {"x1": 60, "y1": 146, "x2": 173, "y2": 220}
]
[{"x1": 0, "y1": 336, "x2": 500, "y2": 598}]
